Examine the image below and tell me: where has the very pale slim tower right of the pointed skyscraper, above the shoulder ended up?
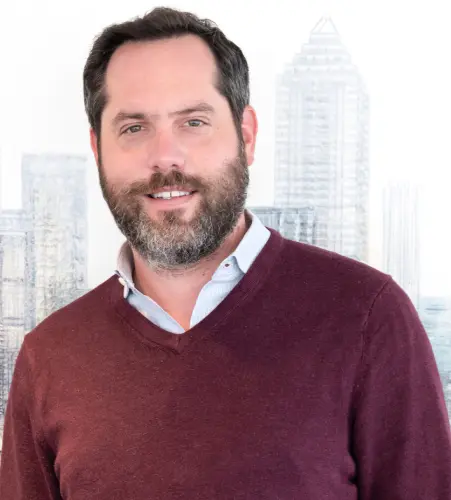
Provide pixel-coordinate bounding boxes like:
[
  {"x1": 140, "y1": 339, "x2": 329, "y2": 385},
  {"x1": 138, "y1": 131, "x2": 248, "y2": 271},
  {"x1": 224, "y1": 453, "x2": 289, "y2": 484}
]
[{"x1": 383, "y1": 183, "x2": 420, "y2": 308}]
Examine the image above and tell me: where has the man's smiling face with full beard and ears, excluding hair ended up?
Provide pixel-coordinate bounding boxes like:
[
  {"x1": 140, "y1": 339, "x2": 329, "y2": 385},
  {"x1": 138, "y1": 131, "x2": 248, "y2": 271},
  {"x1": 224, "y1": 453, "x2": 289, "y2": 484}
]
[{"x1": 91, "y1": 36, "x2": 256, "y2": 269}]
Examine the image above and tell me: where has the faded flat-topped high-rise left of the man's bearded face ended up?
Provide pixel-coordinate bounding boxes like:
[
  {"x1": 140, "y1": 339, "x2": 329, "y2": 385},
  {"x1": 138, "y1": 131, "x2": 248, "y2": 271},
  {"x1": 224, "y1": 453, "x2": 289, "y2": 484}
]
[{"x1": 22, "y1": 155, "x2": 88, "y2": 323}]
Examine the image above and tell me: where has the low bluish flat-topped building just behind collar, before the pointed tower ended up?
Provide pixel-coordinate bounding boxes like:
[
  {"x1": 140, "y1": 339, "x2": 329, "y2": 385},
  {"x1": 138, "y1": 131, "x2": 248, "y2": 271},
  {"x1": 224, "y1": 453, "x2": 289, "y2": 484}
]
[{"x1": 249, "y1": 207, "x2": 318, "y2": 245}]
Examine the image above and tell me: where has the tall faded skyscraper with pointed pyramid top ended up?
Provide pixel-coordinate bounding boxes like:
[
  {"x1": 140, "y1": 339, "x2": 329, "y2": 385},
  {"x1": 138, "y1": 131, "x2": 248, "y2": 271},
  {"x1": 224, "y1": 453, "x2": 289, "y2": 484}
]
[{"x1": 274, "y1": 18, "x2": 369, "y2": 261}]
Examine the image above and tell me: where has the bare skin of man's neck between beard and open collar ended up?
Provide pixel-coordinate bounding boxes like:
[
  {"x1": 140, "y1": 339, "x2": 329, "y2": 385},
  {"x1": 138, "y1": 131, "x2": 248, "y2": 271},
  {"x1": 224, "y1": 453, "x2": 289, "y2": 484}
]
[{"x1": 132, "y1": 213, "x2": 250, "y2": 329}]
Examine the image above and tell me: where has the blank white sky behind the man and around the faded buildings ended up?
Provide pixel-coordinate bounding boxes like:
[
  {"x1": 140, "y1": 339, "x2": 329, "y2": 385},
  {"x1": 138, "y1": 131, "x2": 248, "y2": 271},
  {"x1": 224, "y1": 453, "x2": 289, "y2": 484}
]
[{"x1": 0, "y1": 0, "x2": 451, "y2": 295}]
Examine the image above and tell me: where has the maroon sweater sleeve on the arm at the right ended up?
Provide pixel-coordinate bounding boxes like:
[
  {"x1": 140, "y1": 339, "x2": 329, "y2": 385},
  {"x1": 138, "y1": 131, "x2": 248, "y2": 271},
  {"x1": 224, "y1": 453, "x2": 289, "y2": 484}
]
[{"x1": 351, "y1": 279, "x2": 451, "y2": 500}]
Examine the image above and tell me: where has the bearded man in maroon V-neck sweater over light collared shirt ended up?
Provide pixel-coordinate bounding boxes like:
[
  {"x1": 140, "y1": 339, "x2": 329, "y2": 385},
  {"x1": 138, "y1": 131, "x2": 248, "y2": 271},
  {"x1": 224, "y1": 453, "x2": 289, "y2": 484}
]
[{"x1": 0, "y1": 8, "x2": 451, "y2": 500}]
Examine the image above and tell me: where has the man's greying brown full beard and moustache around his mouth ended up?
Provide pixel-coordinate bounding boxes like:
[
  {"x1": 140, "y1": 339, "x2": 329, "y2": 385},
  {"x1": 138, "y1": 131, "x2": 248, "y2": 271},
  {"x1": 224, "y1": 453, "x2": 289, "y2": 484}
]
[{"x1": 99, "y1": 141, "x2": 249, "y2": 270}]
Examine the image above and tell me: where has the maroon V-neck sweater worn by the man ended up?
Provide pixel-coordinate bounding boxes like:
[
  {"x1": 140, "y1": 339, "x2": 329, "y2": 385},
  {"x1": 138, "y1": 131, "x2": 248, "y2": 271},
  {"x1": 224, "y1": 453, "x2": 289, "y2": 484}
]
[{"x1": 0, "y1": 232, "x2": 451, "y2": 500}]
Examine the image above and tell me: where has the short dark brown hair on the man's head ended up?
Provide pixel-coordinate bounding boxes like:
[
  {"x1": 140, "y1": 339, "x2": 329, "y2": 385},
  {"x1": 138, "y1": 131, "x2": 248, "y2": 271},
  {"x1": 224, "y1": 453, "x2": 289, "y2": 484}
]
[{"x1": 83, "y1": 7, "x2": 249, "y2": 140}]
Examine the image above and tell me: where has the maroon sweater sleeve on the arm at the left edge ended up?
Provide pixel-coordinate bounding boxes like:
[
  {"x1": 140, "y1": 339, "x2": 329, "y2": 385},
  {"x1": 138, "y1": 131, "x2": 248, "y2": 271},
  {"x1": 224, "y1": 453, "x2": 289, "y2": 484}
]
[{"x1": 0, "y1": 339, "x2": 62, "y2": 500}]
